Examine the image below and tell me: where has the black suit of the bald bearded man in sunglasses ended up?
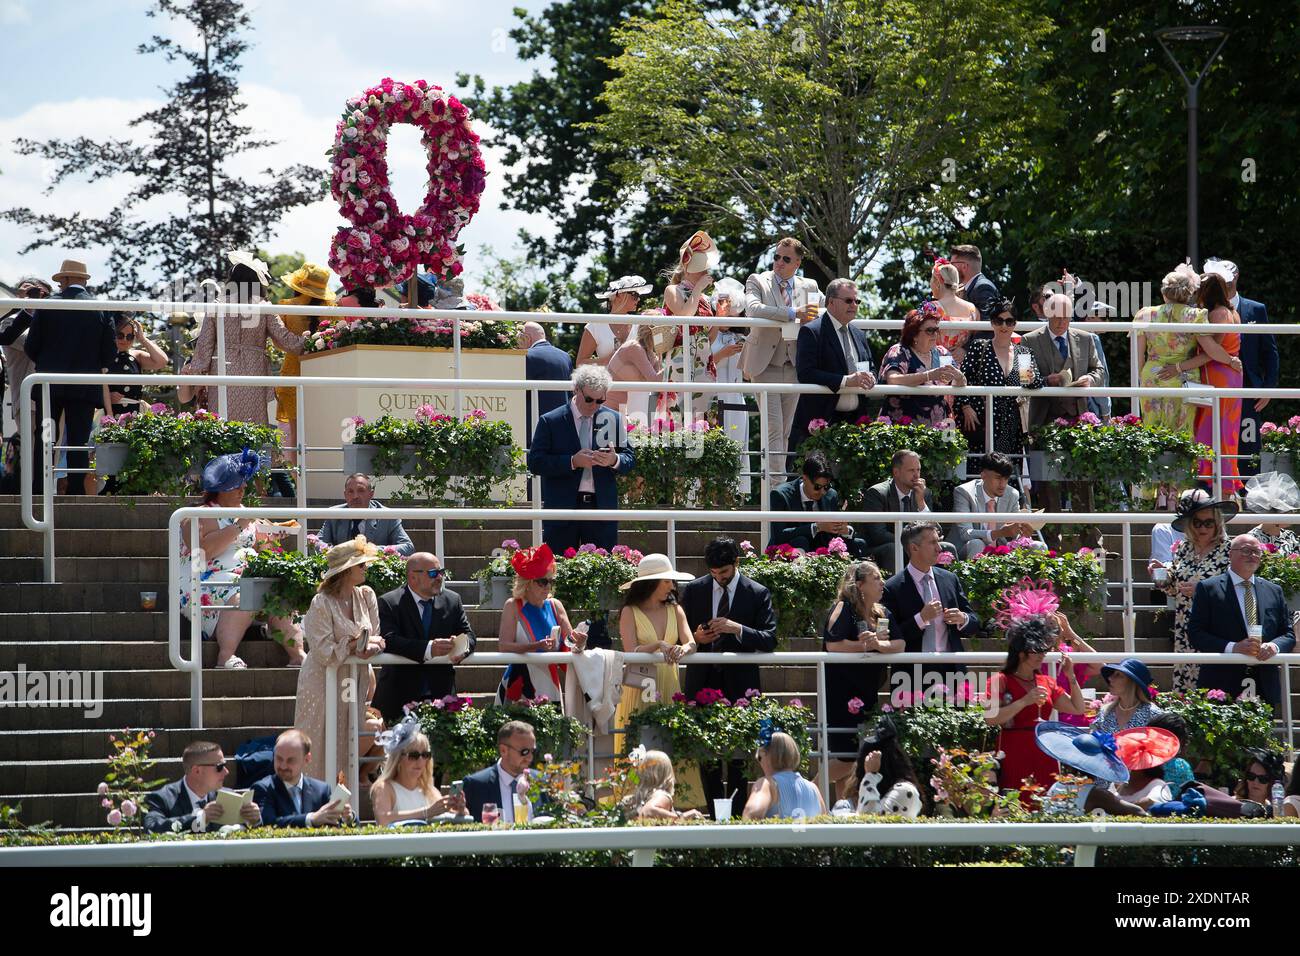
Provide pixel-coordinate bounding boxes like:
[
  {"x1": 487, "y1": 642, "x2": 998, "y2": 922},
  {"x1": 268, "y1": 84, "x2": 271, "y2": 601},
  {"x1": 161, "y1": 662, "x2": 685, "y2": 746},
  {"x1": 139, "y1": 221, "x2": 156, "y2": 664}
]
[{"x1": 374, "y1": 584, "x2": 477, "y2": 722}]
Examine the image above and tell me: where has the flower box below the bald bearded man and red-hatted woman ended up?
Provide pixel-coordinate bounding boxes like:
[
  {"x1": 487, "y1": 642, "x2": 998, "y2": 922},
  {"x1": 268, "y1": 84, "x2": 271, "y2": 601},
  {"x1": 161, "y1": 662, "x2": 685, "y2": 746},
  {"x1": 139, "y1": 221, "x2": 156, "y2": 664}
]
[{"x1": 406, "y1": 695, "x2": 588, "y2": 780}]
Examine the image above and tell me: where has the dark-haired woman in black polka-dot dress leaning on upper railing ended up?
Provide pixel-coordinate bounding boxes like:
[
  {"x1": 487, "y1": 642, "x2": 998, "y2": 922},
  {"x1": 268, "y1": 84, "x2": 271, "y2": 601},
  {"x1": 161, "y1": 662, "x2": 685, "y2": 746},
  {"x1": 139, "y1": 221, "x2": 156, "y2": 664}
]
[{"x1": 957, "y1": 299, "x2": 1043, "y2": 458}]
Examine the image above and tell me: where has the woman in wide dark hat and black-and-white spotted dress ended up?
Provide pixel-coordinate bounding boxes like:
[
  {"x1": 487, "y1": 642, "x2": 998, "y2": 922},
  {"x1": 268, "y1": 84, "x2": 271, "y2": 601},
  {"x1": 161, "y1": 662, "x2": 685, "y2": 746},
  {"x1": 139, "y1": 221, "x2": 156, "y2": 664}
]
[{"x1": 1151, "y1": 496, "x2": 1238, "y2": 693}]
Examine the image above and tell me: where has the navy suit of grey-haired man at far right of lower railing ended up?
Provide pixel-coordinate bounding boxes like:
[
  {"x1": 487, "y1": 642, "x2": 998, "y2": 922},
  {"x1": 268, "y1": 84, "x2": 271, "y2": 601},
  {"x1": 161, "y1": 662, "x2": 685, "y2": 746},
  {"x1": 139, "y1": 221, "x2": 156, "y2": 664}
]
[{"x1": 1187, "y1": 571, "x2": 1296, "y2": 708}]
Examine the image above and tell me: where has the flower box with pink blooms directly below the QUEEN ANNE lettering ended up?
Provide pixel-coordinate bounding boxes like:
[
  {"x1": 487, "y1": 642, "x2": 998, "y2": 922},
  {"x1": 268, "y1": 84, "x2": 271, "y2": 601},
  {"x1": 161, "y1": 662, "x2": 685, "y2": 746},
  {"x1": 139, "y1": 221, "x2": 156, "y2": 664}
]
[{"x1": 343, "y1": 405, "x2": 524, "y2": 507}]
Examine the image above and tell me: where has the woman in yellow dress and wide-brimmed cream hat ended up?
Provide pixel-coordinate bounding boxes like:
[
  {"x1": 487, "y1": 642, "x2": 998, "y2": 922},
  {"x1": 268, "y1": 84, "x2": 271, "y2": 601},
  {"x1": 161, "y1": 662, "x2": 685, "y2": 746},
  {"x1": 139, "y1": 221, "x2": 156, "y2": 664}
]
[{"x1": 614, "y1": 554, "x2": 705, "y2": 801}]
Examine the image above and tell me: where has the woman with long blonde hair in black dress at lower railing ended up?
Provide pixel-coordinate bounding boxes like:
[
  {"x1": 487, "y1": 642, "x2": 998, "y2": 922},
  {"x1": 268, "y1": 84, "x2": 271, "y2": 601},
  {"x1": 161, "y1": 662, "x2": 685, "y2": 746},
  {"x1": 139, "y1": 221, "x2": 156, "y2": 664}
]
[{"x1": 822, "y1": 561, "x2": 905, "y2": 799}]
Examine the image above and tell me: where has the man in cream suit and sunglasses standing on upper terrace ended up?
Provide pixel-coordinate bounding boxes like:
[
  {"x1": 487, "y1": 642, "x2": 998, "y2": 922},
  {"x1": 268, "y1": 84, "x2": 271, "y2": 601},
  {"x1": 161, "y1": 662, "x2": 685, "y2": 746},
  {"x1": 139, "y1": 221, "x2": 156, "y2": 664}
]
[{"x1": 740, "y1": 237, "x2": 818, "y2": 473}]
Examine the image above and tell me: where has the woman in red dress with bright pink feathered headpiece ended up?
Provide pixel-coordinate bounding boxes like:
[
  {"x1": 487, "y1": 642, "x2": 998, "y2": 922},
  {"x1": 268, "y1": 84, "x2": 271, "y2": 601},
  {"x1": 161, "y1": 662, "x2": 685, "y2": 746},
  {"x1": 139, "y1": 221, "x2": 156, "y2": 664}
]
[{"x1": 984, "y1": 615, "x2": 1086, "y2": 810}]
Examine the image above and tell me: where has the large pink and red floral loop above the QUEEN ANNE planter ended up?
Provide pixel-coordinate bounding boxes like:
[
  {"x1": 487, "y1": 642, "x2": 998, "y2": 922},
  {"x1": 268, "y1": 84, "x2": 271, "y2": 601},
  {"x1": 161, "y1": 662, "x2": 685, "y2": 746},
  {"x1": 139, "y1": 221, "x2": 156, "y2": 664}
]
[{"x1": 329, "y1": 79, "x2": 485, "y2": 291}]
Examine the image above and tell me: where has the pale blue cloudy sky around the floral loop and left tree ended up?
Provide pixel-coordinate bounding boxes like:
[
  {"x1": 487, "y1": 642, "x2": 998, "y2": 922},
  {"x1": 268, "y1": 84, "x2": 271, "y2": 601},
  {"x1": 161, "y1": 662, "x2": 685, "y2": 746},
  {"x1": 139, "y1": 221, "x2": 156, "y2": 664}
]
[{"x1": 0, "y1": 0, "x2": 549, "y2": 287}]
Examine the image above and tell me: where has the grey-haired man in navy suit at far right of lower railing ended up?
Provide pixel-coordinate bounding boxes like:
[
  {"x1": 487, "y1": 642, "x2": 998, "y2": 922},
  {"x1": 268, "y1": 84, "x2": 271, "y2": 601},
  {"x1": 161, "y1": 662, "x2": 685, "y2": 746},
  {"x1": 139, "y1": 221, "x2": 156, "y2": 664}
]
[{"x1": 1187, "y1": 535, "x2": 1296, "y2": 711}]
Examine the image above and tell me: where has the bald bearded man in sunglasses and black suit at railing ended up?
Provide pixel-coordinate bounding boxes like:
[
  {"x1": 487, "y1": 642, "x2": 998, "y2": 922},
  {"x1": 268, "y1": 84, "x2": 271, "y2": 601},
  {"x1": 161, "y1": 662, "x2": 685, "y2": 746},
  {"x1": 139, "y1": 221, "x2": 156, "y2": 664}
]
[{"x1": 374, "y1": 551, "x2": 476, "y2": 723}]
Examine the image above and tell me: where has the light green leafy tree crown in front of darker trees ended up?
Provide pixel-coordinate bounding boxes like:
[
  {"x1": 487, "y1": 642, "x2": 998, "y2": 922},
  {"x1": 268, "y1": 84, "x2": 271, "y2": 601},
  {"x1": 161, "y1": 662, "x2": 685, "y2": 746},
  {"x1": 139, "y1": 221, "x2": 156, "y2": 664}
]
[{"x1": 590, "y1": 0, "x2": 1050, "y2": 278}]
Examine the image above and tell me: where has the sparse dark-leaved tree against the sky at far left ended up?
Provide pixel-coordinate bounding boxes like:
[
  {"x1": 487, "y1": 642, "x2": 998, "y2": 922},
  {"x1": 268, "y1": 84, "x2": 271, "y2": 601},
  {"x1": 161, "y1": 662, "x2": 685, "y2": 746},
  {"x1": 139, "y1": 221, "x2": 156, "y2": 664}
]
[{"x1": 0, "y1": 0, "x2": 325, "y2": 295}]
